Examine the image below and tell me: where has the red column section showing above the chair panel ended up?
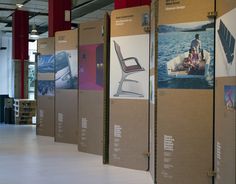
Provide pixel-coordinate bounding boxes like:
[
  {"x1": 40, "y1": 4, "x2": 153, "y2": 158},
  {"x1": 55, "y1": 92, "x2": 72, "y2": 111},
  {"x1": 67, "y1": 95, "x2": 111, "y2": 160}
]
[{"x1": 114, "y1": 0, "x2": 151, "y2": 9}]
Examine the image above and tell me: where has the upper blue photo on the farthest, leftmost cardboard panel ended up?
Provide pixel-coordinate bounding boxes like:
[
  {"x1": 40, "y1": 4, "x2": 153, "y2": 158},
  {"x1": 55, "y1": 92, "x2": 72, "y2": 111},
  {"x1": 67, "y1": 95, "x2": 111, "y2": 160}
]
[{"x1": 38, "y1": 55, "x2": 54, "y2": 73}]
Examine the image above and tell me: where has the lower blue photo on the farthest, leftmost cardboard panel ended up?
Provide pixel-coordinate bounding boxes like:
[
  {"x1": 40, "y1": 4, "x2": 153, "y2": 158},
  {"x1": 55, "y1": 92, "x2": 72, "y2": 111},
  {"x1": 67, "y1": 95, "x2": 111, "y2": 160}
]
[{"x1": 38, "y1": 80, "x2": 55, "y2": 96}]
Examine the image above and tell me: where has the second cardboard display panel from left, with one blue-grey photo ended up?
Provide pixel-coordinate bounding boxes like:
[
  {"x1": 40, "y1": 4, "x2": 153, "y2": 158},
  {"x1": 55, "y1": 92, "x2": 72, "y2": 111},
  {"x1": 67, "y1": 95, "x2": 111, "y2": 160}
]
[{"x1": 55, "y1": 29, "x2": 78, "y2": 144}]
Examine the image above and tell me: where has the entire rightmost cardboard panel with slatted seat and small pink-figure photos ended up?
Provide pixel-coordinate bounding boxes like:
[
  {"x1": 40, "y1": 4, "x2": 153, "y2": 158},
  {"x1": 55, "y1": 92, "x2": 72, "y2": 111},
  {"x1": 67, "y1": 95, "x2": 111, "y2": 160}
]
[{"x1": 214, "y1": 0, "x2": 236, "y2": 184}]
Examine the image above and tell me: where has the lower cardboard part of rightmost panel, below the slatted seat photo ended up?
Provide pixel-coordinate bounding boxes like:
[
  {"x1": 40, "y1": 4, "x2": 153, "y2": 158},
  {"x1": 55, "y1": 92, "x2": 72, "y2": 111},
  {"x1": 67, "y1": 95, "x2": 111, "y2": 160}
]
[{"x1": 215, "y1": 77, "x2": 236, "y2": 184}]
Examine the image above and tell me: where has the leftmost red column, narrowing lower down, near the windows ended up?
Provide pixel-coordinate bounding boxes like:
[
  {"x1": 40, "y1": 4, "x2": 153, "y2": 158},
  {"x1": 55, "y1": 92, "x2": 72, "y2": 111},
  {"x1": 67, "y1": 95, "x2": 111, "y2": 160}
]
[{"x1": 12, "y1": 10, "x2": 29, "y2": 98}]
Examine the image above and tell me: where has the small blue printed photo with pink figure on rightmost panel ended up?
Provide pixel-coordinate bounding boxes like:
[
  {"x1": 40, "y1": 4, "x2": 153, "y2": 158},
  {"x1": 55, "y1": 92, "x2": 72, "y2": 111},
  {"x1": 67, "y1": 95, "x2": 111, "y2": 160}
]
[{"x1": 224, "y1": 86, "x2": 236, "y2": 110}]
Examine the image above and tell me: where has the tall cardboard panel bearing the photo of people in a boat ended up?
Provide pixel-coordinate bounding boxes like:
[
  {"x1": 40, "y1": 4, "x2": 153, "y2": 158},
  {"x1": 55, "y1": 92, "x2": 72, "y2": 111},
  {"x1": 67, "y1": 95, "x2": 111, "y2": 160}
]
[{"x1": 156, "y1": 0, "x2": 214, "y2": 184}]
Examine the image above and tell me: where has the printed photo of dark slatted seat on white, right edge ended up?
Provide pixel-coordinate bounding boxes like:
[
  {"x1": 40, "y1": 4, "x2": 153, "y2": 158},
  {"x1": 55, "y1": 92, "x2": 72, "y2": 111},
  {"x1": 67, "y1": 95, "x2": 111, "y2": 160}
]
[{"x1": 216, "y1": 8, "x2": 236, "y2": 77}]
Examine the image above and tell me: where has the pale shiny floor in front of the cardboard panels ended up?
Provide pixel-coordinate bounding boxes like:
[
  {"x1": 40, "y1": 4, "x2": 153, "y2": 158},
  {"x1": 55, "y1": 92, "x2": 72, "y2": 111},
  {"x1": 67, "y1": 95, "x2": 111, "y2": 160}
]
[{"x1": 0, "y1": 124, "x2": 153, "y2": 184}]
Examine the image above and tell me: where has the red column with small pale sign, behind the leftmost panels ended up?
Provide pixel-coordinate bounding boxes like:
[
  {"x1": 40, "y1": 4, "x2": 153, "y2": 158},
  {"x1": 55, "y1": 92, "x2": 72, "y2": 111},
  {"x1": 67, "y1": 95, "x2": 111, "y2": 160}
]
[{"x1": 48, "y1": 0, "x2": 72, "y2": 37}]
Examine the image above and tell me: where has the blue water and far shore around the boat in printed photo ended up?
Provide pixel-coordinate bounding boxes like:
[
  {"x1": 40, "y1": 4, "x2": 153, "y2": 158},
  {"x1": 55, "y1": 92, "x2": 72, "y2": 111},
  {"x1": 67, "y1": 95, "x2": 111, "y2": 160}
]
[{"x1": 158, "y1": 28, "x2": 214, "y2": 89}]
